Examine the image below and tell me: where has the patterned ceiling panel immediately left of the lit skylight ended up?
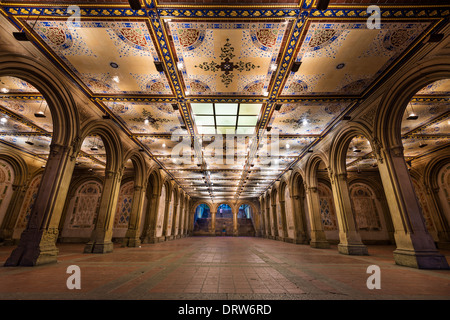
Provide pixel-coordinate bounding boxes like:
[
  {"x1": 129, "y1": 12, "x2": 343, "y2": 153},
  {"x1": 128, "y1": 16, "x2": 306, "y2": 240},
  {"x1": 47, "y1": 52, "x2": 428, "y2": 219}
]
[{"x1": 104, "y1": 102, "x2": 185, "y2": 134}]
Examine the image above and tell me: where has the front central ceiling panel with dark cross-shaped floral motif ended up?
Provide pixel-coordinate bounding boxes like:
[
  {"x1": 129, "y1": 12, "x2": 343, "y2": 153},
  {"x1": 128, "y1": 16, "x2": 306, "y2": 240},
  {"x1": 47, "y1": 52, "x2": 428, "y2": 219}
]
[{"x1": 169, "y1": 22, "x2": 286, "y2": 95}]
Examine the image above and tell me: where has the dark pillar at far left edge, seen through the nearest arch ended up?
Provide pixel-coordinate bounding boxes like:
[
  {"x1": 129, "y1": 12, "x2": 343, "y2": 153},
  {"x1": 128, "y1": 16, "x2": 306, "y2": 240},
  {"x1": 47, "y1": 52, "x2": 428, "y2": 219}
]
[{"x1": 0, "y1": 184, "x2": 27, "y2": 246}]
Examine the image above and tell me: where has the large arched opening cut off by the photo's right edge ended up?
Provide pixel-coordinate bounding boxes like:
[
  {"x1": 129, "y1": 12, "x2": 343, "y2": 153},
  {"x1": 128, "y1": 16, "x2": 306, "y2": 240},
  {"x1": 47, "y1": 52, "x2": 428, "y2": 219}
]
[{"x1": 399, "y1": 79, "x2": 450, "y2": 248}]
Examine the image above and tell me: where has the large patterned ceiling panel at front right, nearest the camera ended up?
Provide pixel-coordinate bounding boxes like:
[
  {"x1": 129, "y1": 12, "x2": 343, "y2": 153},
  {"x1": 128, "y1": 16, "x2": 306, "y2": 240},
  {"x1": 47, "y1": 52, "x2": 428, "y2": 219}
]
[{"x1": 282, "y1": 22, "x2": 429, "y2": 95}]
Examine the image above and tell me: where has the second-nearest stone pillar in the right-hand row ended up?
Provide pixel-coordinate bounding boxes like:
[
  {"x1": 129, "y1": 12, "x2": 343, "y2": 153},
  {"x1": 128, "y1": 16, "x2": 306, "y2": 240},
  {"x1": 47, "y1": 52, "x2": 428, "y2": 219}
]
[{"x1": 329, "y1": 169, "x2": 369, "y2": 255}]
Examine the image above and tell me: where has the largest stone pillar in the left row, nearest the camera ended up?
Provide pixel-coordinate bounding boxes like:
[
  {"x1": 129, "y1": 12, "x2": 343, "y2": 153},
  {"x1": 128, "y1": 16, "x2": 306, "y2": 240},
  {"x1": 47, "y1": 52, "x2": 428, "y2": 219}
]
[{"x1": 5, "y1": 144, "x2": 76, "y2": 266}]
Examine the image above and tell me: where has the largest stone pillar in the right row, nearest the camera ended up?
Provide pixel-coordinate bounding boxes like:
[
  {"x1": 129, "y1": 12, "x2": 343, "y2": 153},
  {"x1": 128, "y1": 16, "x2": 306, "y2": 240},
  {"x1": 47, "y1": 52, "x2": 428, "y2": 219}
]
[{"x1": 377, "y1": 146, "x2": 449, "y2": 269}]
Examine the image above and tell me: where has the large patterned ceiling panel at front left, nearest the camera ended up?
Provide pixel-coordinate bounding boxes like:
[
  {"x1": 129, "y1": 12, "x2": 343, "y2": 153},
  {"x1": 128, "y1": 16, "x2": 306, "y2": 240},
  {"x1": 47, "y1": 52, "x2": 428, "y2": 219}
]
[{"x1": 29, "y1": 21, "x2": 172, "y2": 94}]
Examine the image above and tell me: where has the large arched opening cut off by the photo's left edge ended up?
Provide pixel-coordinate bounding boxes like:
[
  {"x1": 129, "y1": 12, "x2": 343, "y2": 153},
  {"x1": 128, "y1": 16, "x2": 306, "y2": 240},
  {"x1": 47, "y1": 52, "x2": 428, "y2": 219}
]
[{"x1": 0, "y1": 76, "x2": 54, "y2": 243}]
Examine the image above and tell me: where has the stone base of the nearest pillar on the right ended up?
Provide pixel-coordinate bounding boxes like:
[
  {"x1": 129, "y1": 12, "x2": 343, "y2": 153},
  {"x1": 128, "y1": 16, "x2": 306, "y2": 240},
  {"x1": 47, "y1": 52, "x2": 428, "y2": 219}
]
[{"x1": 394, "y1": 249, "x2": 450, "y2": 269}]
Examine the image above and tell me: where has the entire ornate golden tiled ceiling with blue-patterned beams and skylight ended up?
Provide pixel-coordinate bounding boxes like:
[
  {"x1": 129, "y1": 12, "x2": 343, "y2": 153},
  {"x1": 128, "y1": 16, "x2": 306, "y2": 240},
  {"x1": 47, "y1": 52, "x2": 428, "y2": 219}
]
[{"x1": 0, "y1": 0, "x2": 450, "y2": 199}]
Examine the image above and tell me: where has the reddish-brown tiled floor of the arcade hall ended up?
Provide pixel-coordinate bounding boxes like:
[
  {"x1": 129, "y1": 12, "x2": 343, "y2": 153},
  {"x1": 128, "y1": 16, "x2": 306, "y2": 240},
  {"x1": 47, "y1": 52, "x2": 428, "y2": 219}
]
[{"x1": 0, "y1": 237, "x2": 450, "y2": 300}]
